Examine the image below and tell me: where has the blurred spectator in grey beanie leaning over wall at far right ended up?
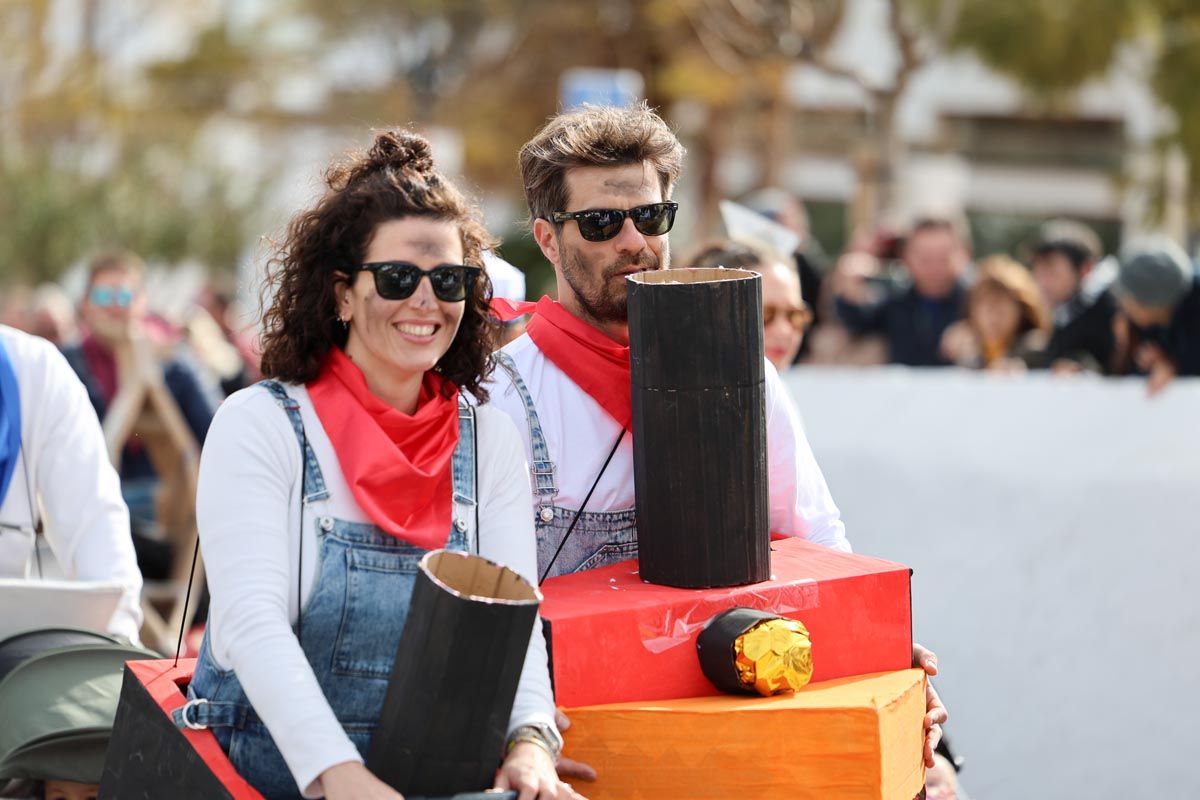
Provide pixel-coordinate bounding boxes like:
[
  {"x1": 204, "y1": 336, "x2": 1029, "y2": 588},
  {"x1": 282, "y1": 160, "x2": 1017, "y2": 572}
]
[{"x1": 1112, "y1": 236, "x2": 1200, "y2": 395}]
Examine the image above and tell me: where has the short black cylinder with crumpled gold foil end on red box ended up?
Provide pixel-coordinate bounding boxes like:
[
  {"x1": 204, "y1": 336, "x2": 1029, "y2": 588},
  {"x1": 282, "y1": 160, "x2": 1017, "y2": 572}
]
[{"x1": 696, "y1": 608, "x2": 812, "y2": 697}]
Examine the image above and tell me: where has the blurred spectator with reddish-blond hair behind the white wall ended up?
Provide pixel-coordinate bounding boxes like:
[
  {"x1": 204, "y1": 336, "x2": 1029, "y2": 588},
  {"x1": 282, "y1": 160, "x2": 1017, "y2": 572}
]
[{"x1": 942, "y1": 255, "x2": 1050, "y2": 372}]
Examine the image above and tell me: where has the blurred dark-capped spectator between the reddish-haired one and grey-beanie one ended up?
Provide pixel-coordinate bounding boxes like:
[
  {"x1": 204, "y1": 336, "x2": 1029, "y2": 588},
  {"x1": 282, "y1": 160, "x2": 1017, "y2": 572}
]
[{"x1": 1028, "y1": 219, "x2": 1117, "y2": 374}]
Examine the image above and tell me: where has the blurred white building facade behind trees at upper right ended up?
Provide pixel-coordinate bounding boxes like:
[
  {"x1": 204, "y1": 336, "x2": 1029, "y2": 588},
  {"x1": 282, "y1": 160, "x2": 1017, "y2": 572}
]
[{"x1": 705, "y1": 0, "x2": 1171, "y2": 255}]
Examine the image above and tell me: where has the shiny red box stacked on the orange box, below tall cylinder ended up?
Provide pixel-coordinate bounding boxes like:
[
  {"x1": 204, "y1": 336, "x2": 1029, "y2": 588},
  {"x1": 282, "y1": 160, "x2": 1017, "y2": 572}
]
[{"x1": 541, "y1": 539, "x2": 912, "y2": 706}]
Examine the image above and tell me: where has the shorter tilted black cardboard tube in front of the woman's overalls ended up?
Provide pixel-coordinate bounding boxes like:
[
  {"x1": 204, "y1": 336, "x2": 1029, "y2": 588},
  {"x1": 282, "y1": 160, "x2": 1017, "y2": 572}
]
[{"x1": 367, "y1": 551, "x2": 541, "y2": 796}]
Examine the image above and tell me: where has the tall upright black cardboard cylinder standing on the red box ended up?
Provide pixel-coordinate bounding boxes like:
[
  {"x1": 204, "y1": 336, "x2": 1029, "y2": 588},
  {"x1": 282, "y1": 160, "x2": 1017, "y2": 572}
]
[{"x1": 628, "y1": 270, "x2": 770, "y2": 588}]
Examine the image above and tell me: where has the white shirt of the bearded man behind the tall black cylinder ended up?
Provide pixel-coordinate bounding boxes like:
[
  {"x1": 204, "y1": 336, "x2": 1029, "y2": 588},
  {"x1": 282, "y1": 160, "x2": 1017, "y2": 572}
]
[{"x1": 488, "y1": 333, "x2": 850, "y2": 552}]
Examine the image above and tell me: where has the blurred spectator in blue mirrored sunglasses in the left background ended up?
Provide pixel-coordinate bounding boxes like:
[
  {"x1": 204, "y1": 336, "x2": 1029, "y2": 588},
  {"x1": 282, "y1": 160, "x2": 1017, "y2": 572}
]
[{"x1": 62, "y1": 252, "x2": 221, "y2": 578}]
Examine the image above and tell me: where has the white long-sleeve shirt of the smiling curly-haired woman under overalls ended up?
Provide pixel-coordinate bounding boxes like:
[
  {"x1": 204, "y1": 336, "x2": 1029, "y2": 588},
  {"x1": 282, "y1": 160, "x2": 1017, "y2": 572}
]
[{"x1": 197, "y1": 386, "x2": 554, "y2": 798}]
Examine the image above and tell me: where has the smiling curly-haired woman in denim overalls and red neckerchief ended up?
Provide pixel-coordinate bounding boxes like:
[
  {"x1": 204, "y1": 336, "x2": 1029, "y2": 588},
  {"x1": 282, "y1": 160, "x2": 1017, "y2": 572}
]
[{"x1": 176, "y1": 132, "x2": 577, "y2": 800}]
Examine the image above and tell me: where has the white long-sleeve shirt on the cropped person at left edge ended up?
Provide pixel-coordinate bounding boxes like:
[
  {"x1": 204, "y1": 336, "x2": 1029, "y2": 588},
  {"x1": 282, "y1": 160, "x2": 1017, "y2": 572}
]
[{"x1": 0, "y1": 325, "x2": 142, "y2": 642}]
